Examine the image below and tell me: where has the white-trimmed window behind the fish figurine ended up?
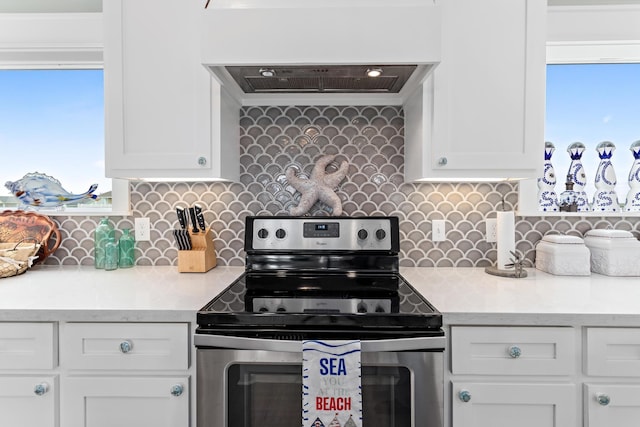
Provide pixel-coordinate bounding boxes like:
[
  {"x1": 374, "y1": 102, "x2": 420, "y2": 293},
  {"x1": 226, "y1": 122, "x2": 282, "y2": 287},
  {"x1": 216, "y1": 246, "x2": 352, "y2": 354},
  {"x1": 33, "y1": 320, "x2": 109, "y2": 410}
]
[{"x1": 0, "y1": 13, "x2": 130, "y2": 215}]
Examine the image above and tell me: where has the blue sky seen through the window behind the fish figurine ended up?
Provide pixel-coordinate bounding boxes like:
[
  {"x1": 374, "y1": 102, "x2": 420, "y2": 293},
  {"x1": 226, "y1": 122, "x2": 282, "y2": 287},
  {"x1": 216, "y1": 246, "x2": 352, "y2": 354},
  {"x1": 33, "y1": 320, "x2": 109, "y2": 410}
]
[{"x1": 0, "y1": 70, "x2": 111, "y2": 206}]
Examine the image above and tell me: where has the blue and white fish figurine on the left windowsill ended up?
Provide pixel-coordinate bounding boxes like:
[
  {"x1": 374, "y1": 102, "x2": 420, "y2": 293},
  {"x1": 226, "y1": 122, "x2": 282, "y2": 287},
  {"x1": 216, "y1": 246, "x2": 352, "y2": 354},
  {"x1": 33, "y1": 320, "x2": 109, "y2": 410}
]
[{"x1": 4, "y1": 172, "x2": 98, "y2": 207}]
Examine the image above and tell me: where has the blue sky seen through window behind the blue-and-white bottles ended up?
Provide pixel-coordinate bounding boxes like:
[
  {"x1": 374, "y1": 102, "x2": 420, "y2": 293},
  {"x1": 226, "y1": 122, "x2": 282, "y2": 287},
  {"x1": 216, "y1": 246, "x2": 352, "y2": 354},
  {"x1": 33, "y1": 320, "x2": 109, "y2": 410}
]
[{"x1": 540, "y1": 63, "x2": 640, "y2": 203}]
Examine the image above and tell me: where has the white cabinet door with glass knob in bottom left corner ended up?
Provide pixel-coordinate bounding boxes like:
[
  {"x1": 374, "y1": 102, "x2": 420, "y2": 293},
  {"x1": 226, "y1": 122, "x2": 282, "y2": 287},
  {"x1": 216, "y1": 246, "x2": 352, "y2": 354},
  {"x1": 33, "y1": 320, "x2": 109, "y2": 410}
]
[{"x1": 0, "y1": 376, "x2": 59, "y2": 427}]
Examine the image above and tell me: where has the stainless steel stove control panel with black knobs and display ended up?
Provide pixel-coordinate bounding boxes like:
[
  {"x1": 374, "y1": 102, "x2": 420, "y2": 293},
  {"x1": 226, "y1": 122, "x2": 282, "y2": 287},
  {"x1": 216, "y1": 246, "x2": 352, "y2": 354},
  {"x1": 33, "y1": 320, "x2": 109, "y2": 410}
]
[{"x1": 245, "y1": 216, "x2": 399, "y2": 251}]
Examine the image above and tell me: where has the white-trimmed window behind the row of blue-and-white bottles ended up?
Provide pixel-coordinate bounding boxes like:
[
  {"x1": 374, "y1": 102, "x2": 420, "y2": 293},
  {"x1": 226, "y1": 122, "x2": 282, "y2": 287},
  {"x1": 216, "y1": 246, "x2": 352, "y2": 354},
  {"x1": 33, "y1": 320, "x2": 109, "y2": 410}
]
[{"x1": 518, "y1": 3, "x2": 640, "y2": 216}]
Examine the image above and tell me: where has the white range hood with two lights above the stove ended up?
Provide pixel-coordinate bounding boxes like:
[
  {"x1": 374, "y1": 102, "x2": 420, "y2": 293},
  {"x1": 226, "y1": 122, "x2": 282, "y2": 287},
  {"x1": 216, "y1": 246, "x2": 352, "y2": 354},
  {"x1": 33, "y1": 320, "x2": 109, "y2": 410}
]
[{"x1": 201, "y1": 0, "x2": 441, "y2": 105}]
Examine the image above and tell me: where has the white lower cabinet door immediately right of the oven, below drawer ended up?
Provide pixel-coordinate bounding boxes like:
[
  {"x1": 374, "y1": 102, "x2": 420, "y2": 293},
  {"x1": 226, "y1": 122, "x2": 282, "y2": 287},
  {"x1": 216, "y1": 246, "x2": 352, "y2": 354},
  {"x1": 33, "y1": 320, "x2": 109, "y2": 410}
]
[{"x1": 452, "y1": 382, "x2": 578, "y2": 427}]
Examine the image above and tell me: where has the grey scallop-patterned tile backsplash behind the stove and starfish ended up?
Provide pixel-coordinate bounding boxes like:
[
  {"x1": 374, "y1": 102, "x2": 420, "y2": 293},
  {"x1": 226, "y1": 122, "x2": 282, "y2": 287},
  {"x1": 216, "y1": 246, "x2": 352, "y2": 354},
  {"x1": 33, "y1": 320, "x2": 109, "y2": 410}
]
[{"x1": 46, "y1": 106, "x2": 640, "y2": 267}]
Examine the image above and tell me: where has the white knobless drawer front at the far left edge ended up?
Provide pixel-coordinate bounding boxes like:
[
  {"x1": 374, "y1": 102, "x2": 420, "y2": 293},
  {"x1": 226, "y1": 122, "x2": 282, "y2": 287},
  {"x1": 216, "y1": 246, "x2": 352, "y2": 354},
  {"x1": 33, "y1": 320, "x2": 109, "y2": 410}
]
[{"x1": 0, "y1": 322, "x2": 58, "y2": 370}]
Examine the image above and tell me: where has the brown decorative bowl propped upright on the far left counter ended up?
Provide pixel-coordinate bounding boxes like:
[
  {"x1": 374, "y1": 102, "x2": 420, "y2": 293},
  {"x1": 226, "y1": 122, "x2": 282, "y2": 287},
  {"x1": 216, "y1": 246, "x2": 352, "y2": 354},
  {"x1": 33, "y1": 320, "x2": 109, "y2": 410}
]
[{"x1": 0, "y1": 210, "x2": 62, "y2": 263}]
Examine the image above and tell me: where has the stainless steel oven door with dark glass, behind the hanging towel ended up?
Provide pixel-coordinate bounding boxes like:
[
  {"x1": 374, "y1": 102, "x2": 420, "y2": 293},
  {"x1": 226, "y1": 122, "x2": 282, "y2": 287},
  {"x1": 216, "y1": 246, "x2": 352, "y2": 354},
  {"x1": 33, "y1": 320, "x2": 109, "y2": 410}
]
[{"x1": 196, "y1": 335, "x2": 444, "y2": 427}]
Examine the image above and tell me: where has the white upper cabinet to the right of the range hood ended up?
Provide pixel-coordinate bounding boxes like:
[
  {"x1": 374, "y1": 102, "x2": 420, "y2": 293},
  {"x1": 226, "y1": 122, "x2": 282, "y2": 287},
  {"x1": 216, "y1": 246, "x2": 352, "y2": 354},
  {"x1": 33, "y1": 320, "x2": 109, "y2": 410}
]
[{"x1": 404, "y1": 0, "x2": 546, "y2": 181}]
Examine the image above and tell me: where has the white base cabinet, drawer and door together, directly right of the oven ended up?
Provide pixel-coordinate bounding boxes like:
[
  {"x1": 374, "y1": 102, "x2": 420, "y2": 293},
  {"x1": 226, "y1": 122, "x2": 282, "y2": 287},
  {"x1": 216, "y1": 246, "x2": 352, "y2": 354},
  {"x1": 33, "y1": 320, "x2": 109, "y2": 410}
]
[{"x1": 450, "y1": 326, "x2": 579, "y2": 427}]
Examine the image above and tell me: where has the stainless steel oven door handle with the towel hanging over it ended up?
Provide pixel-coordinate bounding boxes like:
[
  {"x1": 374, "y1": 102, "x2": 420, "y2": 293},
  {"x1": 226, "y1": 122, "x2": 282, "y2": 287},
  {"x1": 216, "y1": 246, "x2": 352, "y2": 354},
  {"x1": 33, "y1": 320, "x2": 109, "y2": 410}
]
[{"x1": 193, "y1": 334, "x2": 446, "y2": 353}]
